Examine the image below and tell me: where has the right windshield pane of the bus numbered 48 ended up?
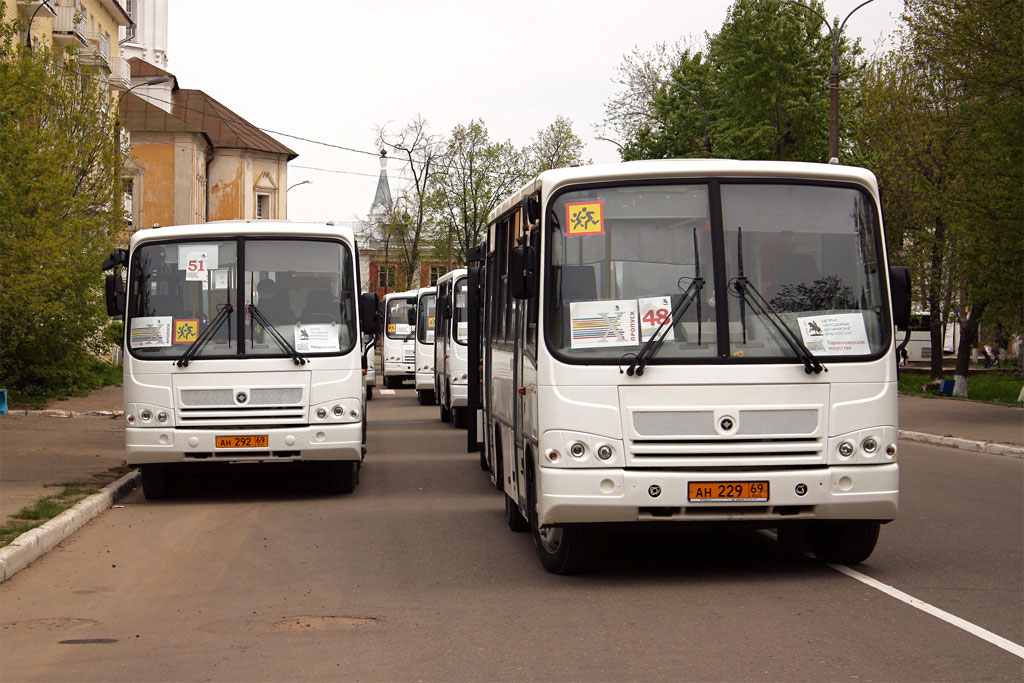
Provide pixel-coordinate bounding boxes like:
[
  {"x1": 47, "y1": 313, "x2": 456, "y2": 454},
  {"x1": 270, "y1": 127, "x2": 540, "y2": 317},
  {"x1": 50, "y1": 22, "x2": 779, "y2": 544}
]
[{"x1": 722, "y1": 183, "x2": 888, "y2": 358}]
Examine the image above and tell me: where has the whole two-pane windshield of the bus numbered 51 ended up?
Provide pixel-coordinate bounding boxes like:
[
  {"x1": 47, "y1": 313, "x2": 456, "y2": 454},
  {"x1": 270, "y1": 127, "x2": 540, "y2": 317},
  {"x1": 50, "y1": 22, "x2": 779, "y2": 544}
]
[{"x1": 127, "y1": 238, "x2": 356, "y2": 359}]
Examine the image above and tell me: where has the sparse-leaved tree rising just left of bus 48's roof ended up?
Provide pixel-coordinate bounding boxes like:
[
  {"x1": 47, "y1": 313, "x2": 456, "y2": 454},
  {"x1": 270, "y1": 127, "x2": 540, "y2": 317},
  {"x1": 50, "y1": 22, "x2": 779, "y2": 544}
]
[{"x1": 430, "y1": 120, "x2": 526, "y2": 269}]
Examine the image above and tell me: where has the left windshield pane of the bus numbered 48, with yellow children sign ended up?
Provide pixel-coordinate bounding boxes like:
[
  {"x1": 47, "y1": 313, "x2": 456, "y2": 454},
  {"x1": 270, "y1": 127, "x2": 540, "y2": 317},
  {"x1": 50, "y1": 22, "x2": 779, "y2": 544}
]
[{"x1": 546, "y1": 184, "x2": 717, "y2": 360}]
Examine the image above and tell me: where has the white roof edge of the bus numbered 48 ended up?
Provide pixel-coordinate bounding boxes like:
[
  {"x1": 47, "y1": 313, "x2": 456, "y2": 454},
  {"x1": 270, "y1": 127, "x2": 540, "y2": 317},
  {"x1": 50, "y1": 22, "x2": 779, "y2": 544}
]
[{"x1": 487, "y1": 159, "x2": 878, "y2": 222}]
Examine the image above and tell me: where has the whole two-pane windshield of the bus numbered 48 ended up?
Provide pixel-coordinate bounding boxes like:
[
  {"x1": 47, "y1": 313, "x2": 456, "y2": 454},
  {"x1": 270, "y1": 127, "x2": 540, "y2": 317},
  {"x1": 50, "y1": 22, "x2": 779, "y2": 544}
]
[{"x1": 546, "y1": 181, "x2": 889, "y2": 364}]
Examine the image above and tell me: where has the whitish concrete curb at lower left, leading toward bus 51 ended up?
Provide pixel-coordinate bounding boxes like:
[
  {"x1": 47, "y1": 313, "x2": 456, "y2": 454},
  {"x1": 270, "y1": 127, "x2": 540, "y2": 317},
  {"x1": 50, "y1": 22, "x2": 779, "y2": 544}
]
[{"x1": 0, "y1": 470, "x2": 140, "y2": 584}]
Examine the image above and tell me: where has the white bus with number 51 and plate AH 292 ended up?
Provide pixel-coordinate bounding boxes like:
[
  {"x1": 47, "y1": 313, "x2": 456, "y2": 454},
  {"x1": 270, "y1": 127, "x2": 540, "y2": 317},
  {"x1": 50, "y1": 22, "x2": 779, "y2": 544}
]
[{"x1": 103, "y1": 220, "x2": 378, "y2": 499}]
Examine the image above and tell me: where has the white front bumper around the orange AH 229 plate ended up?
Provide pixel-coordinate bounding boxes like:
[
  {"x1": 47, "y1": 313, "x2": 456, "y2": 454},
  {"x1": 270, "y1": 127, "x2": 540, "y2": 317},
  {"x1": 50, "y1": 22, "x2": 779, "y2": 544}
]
[{"x1": 539, "y1": 463, "x2": 899, "y2": 526}]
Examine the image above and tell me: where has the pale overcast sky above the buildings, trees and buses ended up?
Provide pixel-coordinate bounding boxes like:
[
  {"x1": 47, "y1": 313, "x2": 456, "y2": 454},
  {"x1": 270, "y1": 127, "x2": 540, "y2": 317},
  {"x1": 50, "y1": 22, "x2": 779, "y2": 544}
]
[{"x1": 167, "y1": 0, "x2": 903, "y2": 220}]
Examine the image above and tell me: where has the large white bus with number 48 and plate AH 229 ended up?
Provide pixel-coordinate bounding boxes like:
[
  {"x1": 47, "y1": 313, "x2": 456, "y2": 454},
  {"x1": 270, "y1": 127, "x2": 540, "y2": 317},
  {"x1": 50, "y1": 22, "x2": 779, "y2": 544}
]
[{"x1": 469, "y1": 160, "x2": 910, "y2": 573}]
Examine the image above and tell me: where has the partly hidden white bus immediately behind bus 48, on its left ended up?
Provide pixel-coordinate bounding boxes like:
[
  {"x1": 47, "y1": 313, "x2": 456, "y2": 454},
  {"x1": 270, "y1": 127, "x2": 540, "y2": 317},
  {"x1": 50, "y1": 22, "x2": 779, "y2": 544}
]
[{"x1": 434, "y1": 268, "x2": 469, "y2": 428}]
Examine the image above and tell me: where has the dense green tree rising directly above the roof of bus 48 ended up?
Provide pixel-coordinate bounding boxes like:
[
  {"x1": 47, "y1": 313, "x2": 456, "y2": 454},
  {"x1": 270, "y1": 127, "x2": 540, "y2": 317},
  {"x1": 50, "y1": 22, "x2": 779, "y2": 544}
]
[{"x1": 623, "y1": 0, "x2": 861, "y2": 162}]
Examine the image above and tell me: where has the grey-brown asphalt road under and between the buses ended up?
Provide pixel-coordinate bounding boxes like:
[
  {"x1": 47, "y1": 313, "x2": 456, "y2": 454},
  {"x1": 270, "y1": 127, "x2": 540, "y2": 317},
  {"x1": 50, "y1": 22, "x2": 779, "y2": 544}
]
[{"x1": 0, "y1": 389, "x2": 1024, "y2": 681}]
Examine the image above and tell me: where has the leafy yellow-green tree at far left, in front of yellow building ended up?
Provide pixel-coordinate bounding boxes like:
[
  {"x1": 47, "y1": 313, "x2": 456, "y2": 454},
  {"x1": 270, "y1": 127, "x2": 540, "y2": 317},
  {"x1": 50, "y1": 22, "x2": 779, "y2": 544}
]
[{"x1": 0, "y1": 24, "x2": 125, "y2": 398}]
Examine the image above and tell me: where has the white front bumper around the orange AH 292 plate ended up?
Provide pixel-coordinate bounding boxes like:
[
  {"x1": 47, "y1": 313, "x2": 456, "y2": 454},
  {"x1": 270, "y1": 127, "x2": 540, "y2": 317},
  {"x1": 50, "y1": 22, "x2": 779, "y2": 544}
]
[{"x1": 125, "y1": 423, "x2": 362, "y2": 465}]
